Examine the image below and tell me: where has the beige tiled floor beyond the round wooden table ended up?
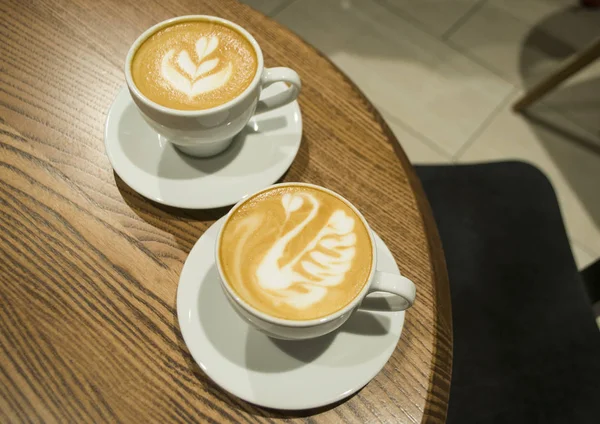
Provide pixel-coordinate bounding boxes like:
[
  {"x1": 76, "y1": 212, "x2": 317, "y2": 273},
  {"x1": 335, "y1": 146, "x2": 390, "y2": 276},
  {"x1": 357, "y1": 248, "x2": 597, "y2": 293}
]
[{"x1": 244, "y1": 0, "x2": 600, "y2": 267}]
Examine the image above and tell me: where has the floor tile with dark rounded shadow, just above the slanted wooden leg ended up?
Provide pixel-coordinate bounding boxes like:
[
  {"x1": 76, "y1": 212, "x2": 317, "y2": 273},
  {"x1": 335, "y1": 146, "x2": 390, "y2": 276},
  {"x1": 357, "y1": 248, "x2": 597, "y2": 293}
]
[{"x1": 449, "y1": 0, "x2": 600, "y2": 88}]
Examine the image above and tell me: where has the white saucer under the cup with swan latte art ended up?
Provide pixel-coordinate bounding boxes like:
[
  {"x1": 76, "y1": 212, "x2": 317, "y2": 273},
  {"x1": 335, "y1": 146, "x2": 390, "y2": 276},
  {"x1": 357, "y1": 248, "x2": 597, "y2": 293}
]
[{"x1": 177, "y1": 219, "x2": 404, "y2": 410}]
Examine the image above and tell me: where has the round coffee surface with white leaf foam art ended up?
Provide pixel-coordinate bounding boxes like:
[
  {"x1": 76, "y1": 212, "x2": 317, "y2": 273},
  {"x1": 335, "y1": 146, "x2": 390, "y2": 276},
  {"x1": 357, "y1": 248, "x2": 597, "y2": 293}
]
[{"x1": 131, "y1": 20, "x2": 258, "y2": 110}]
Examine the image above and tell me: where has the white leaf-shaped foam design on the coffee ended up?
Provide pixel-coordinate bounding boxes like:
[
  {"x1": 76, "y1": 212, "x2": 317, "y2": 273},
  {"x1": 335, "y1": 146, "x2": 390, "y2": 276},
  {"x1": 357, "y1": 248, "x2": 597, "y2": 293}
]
[{"x1": 161, "y1": 36, "x2": 233, "y2": 97}]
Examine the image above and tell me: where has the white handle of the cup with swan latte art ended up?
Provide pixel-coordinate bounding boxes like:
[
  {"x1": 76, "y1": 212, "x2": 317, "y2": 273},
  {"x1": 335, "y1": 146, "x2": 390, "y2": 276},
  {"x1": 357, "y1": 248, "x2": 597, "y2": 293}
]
[{"x1": 360, "y1": 271, "x2": 417, "y2": 312}]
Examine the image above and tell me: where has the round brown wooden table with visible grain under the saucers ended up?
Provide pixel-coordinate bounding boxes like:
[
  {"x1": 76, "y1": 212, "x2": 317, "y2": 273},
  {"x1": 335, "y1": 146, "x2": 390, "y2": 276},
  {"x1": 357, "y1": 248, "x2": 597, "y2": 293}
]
[{"x1": 0, "y1": 0, "x2": 452, "y2": 423}]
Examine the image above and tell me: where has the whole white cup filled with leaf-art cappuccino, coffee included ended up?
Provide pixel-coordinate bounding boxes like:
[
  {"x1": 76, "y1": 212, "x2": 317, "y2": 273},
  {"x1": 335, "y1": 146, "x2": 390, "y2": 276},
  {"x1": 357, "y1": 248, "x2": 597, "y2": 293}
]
[{"x1": 125, "y1": 15, "x2": 302, "y2": 157}]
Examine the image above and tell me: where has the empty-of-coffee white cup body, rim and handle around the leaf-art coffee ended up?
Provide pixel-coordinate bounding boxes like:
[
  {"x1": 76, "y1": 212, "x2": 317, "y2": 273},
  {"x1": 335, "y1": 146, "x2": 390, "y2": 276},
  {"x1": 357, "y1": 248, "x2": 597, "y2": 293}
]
[{"x1": 125, "y1": 15, "x2": 301, "y2": 157}]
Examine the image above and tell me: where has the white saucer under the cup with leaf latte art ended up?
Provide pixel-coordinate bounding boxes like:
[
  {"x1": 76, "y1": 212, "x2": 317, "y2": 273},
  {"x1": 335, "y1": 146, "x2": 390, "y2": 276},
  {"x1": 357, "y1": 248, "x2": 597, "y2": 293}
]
[{"x1": 104, "y1": 83, "x2": 302, "y2": 209}]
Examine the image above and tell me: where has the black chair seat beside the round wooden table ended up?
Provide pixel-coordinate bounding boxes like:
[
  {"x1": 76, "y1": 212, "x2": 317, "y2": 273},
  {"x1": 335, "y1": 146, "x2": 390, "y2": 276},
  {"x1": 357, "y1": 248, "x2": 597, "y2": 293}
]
[{"x1": 416, "y1": 162, "x2": 600, "y2": 424}]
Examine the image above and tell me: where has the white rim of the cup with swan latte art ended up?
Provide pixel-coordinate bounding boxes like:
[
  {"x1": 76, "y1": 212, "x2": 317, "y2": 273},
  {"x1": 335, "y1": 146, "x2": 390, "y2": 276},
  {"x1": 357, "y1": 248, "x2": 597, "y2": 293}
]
[{"x1": 215, "y1": 182, "x2": 377, "y2": 327}]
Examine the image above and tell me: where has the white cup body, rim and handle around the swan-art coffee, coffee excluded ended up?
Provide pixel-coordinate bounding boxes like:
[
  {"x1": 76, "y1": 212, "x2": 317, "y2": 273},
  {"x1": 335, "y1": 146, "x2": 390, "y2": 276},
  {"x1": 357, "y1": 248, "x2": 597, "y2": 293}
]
[{"x1": 215, "y1": 183, "x2": 416, "y2": 340}]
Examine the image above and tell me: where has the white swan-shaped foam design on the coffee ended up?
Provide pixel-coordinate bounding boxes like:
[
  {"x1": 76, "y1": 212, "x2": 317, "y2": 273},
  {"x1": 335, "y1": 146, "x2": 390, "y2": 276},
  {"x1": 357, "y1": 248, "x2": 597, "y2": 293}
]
[{"x1": 256, "y1": 193, "x2": 356, "y2": 309}]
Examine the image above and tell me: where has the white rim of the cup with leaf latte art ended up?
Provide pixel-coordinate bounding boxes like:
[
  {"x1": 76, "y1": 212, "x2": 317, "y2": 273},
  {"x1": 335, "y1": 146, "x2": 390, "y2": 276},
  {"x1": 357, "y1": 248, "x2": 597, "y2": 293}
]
[{"x1": 125, "y1": 15, "x2": 264, "y2": 116}]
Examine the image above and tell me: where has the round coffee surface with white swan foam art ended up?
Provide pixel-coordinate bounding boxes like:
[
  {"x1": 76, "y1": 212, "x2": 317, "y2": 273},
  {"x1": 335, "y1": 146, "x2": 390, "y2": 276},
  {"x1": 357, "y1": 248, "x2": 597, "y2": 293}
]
[{"x1": 218, "y1": 185, "x2": 373, "y2": 320}]
